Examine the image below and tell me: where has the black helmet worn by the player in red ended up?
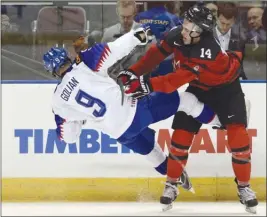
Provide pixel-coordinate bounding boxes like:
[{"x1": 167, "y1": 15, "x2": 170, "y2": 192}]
[{"x1": 184, "y1": 5, "x2": 216, "y2": 32}]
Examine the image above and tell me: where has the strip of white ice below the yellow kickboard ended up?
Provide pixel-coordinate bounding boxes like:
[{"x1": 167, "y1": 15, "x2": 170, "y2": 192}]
[{"x1": 2, "y1": 202, "x2": 266, "y2": 216}]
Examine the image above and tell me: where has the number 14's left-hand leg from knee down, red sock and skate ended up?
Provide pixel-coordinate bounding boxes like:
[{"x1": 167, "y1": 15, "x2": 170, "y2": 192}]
[{"x1": 160, "y1": 112, "x2": 202, "y2": 210}]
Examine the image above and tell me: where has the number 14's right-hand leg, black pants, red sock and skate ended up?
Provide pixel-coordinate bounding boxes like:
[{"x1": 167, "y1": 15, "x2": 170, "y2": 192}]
[{"x1": 218, "y1": 81, "x2": 258, "y2": 213}]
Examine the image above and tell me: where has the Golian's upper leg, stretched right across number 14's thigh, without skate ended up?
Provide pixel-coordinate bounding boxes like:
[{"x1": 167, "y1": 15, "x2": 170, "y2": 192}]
[{"x1": 119, "y1": 91, "x2": 220, "y2": 141}]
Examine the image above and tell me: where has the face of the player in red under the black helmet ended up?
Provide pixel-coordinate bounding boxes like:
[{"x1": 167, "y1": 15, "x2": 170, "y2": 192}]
[{"x1": 182, "y1": 19, "x2": 200, "y2": 44}]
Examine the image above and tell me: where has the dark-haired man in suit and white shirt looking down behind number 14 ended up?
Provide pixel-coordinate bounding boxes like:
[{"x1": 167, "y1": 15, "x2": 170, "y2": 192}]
[{"x1": 214, "y1": 2, "x2": 247, "y2": 80}]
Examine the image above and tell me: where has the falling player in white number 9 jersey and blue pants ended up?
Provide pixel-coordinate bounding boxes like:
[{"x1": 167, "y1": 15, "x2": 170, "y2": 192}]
[{"x1": 43, "y1": 25, "x2": 223, "y2": 193}]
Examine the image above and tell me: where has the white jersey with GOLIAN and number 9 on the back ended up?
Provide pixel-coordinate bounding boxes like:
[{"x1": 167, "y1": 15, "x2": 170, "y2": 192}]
[{"x1": 52, "y1": 31, "x2": 144, "y2": 143}]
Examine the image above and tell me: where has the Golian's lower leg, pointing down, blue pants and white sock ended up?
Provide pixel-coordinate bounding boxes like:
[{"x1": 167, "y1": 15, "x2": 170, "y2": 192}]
[{"x1": 118, "y1": 127, "x2": 167, "y2": 175}]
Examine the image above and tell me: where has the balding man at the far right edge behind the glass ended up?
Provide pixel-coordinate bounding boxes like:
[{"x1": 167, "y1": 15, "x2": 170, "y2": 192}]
[{"x1": 247, "y1": 7, "x2": 266, "y2": 45}]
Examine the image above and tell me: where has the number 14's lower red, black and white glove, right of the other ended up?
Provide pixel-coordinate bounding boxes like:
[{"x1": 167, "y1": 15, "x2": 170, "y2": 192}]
[{"x1": 125, "y1": 75, "x2": 153, "y2": 98}]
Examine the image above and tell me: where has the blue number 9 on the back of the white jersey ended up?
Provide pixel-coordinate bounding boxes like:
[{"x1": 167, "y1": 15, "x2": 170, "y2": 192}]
[{"x1": 75, "y1": 90, "x2": 107, "y2": 118}]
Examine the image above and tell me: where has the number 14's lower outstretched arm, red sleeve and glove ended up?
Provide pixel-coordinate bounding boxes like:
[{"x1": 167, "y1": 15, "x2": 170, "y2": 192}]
[{"x1": 125, "y1": 49, "x2": 236, "y2": 98}]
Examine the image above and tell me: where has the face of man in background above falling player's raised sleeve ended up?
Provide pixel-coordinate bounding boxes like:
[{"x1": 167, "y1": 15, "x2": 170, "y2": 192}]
[{"x1": 118, "y1": 5, "x2": 135, "y2": 32}]
